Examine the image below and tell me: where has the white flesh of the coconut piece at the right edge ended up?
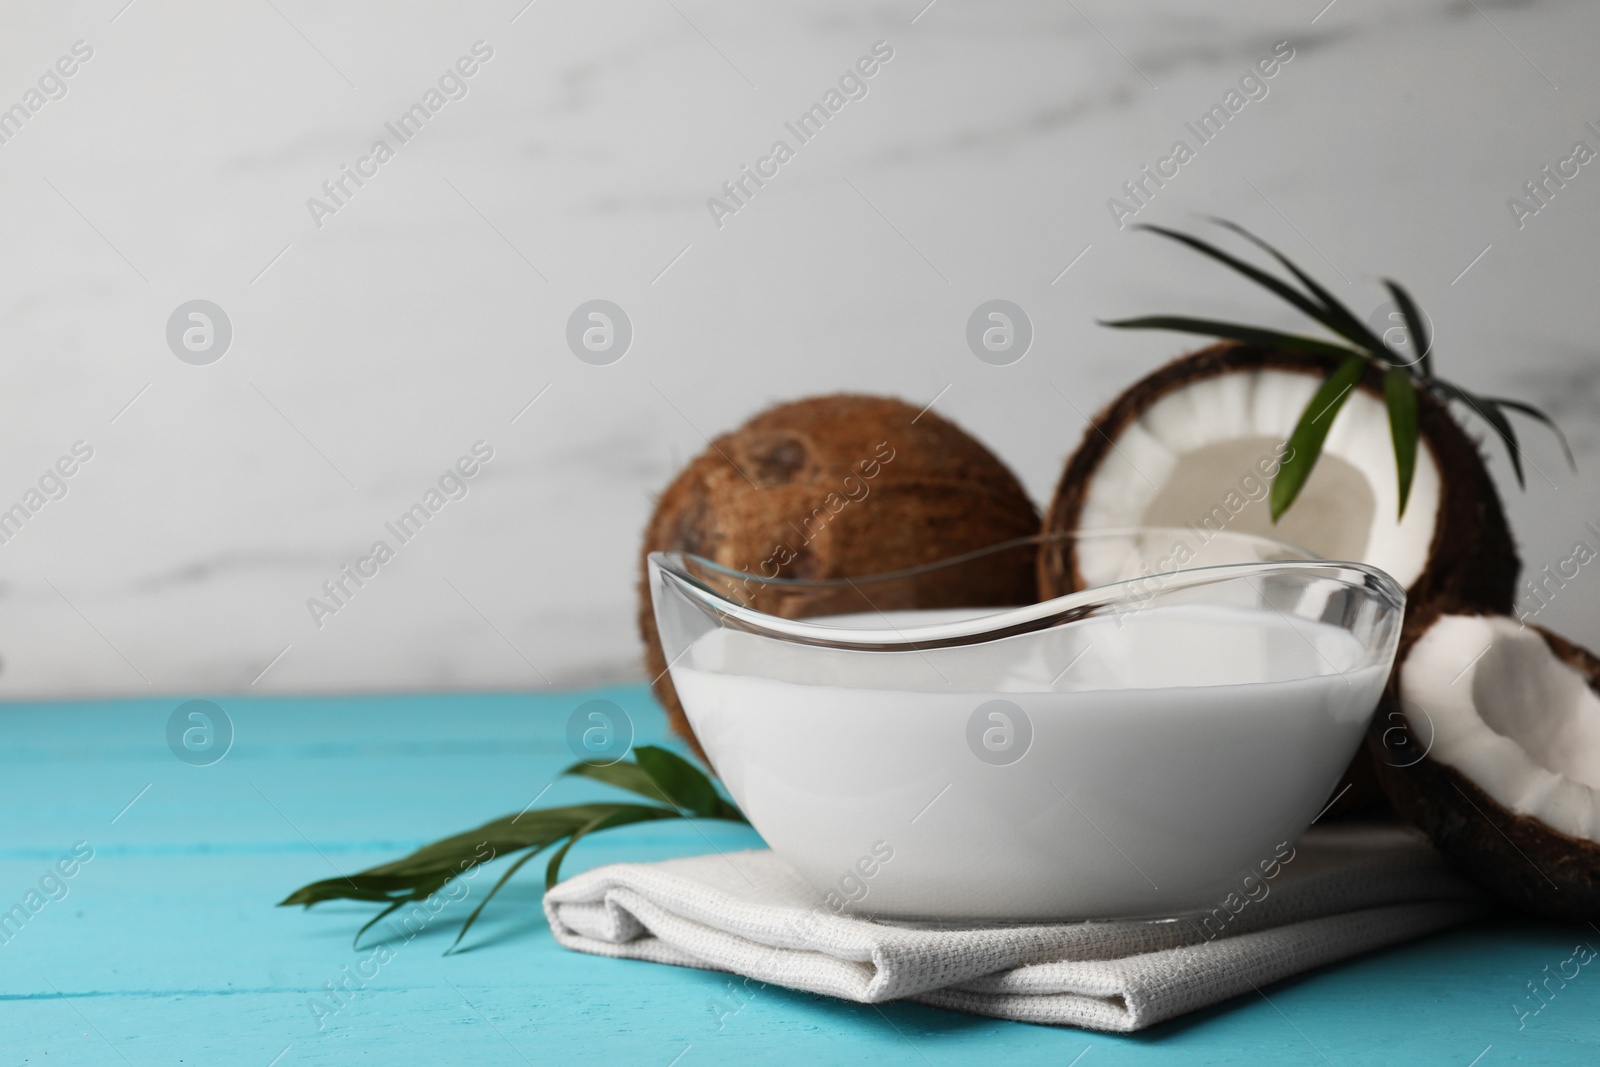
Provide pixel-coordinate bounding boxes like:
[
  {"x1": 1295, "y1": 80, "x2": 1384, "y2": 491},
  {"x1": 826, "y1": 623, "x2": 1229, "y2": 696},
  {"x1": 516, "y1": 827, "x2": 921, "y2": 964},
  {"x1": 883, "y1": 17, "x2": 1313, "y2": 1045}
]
[{"x1": 1400, "y1": 614, "x2": 1600, "y2": 843}]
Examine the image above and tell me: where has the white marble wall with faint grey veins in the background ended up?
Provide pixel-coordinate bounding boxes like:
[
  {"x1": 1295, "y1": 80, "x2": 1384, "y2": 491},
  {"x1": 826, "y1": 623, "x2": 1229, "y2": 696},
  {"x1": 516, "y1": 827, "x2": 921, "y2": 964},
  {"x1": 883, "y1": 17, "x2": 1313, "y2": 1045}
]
[{"x1": 0, "y1": 0, "x2": 1600, "y2": 696}]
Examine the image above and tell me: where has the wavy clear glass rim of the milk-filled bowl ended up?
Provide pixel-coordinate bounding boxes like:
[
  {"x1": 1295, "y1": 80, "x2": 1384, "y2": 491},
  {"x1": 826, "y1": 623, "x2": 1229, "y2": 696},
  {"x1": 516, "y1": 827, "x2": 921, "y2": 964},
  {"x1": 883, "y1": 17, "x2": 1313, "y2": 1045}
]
[{"x1": 646, "y1": 526, "x2": 1406, "y2": 651}]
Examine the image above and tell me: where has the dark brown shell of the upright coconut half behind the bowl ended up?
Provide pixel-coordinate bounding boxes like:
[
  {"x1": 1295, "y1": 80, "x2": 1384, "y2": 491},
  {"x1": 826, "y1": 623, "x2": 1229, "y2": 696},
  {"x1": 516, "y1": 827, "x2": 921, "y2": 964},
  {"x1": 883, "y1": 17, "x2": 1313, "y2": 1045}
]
[{"x1": 1038, "y1": 342, "x2": 1522, "y2": 819}]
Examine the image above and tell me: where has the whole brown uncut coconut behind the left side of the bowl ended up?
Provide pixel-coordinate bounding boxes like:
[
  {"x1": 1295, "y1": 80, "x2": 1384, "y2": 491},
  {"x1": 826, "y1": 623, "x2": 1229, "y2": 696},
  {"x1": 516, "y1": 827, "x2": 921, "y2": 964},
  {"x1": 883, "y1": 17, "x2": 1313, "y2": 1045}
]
[{"x1": 638, "y1": 394, "x2": 1038, "y2": 760}]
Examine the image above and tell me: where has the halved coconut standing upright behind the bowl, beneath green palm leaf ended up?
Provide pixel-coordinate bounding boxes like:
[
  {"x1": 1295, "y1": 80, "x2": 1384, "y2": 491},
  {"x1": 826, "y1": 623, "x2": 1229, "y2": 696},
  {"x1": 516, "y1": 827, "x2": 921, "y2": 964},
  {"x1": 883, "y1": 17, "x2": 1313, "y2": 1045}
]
[{"x1": 1038, "y1": 342, "x2": 1520, "y2": 816}]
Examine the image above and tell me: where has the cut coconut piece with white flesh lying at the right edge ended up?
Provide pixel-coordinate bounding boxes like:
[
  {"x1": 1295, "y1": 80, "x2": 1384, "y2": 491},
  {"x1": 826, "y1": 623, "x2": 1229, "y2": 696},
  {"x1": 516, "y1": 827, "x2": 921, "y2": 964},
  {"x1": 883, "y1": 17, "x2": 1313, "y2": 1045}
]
[{"x1": 1368, "y1": 614, "x2": 1600, "y2": 920}]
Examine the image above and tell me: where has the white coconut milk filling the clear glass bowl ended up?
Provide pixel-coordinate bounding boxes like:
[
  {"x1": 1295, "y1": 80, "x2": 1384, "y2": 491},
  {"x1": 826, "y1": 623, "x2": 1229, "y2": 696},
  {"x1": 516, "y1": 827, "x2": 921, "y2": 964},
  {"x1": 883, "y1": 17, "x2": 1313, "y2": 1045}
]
[{"x1": 672, "y1": 605, "x2": 1387, "y2": 918}]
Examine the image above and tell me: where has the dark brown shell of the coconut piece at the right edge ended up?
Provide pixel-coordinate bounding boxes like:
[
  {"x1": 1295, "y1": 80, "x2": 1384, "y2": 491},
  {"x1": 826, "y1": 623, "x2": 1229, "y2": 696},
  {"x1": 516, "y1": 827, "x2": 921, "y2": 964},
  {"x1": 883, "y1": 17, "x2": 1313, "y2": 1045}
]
[{"x1": 1366, "y1": 605, "x2": 1600, "y2": 921}]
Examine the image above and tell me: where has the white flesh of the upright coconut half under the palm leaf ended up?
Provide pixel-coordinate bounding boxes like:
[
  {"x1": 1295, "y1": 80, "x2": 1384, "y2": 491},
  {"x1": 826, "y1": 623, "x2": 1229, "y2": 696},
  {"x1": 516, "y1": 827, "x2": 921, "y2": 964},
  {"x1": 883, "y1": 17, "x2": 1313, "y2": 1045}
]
[{"x1": 1077, "y1": 370, "x2": 1440, "y2": 589}]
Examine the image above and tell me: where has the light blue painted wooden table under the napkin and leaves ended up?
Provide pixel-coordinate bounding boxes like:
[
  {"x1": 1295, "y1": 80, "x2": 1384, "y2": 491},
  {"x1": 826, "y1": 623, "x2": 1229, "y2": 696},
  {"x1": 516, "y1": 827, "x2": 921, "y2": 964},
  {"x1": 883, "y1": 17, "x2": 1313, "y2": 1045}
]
[{"x1": 0, "y1": 686, "x2": 1600, "y2": 1067}]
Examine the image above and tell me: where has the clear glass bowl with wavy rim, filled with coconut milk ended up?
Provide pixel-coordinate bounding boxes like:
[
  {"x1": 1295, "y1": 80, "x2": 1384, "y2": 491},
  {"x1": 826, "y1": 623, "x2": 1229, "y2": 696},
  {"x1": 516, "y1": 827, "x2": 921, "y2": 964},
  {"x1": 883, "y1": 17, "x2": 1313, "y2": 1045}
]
[{"x1": 650, "y1": 528, "x2": 1405, "y2": 920}]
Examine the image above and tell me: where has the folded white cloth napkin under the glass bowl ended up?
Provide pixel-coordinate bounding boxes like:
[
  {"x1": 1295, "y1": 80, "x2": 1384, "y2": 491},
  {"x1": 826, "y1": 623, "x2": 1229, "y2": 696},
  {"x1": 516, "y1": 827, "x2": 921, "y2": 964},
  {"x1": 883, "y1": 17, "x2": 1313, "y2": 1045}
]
[{"x1": 544, "y1": 827, "x2": 1485, "y2": 1032}]
